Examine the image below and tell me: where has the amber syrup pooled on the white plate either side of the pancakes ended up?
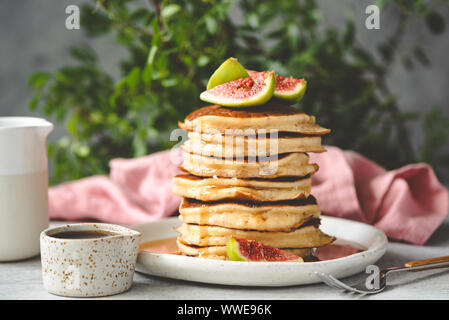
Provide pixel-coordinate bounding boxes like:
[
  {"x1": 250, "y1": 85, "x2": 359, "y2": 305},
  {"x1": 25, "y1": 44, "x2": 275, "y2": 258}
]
[{"x1": 139, "y1": 237, "x2": 365, "y2": 262}]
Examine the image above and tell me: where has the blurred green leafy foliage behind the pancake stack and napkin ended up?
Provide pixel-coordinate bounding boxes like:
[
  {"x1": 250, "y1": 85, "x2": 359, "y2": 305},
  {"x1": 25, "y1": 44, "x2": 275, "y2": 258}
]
[{"x1": 29, "y1": 0, "x2": 449, "y2": 184}]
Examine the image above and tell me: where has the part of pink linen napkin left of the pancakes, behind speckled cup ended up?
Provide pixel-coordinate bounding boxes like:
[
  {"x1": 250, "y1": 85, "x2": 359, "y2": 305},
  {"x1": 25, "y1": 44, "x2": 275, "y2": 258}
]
[{"x1": 48, "y1": 150, "x2": 181, "y2": 225}]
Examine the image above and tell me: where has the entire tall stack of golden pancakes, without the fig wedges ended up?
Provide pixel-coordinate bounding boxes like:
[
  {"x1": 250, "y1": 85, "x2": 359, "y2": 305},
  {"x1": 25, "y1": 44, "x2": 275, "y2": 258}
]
[{"x1": 173, "y1": 103, "x2": 335, "y2": 259}]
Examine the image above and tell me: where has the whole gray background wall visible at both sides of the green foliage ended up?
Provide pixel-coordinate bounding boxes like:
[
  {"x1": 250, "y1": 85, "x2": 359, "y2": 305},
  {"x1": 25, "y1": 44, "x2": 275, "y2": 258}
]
[{"x1": 0, "y1": 0, "x2": 449, "y2": 169}]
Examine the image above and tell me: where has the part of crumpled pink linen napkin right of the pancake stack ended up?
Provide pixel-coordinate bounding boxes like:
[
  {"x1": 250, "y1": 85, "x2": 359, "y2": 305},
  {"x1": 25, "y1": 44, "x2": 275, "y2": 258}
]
[{"x1": 310, "y1": 146, "x2": 449, "y2": 245}]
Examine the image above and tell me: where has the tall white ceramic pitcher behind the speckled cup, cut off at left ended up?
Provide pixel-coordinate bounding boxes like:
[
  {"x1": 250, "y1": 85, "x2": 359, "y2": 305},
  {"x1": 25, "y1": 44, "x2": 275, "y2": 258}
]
[{"x1": 0, "y1": 117, "x2": 53, "y2": 261}]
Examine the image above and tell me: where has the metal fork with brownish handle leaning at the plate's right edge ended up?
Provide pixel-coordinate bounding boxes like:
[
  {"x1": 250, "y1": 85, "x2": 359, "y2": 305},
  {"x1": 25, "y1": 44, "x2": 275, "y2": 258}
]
[{"x1": 315, "y1": 256, "x2": 449, "y2": 295}]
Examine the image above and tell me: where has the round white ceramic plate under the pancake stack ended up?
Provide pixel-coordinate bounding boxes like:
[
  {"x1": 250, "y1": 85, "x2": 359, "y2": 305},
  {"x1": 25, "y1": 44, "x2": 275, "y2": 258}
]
[{"x1": 132, "y1": 216, "x2": 388, "y2": 287}]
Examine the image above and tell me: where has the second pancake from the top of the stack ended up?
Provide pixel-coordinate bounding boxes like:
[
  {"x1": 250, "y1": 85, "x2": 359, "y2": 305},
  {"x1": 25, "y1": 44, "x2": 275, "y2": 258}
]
[{"x1": 181, "y1": 132, "x2": 326, "y2": 158}]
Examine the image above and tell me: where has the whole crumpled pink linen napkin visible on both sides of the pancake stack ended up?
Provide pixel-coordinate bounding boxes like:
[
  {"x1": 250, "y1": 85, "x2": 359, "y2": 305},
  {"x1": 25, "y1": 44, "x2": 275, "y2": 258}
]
[{"x1": 49, "y1": 147, "x2": 449, "y2": 244}]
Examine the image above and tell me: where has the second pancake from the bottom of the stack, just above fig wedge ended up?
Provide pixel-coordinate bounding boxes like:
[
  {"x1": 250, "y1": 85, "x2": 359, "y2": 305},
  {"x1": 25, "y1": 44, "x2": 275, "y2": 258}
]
[{"x1": 176, "y1": 223, "x2": 335, "y2": 248}]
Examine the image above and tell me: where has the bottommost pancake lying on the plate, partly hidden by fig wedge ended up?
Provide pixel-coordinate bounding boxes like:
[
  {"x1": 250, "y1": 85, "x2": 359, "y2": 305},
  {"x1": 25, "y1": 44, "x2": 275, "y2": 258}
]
[{"x1": 176, "y1": 238, "x2": 312, "y2": 260}]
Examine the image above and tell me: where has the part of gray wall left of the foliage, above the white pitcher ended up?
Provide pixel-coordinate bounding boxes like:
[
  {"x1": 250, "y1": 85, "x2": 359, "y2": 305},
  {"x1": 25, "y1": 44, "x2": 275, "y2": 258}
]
[{"x1": 0, "y1": 0, "x2": 126, "y2": 140}]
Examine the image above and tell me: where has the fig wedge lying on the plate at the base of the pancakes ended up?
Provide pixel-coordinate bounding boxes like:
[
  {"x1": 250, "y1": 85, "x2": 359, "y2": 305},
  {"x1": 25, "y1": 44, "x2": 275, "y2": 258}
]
[{"x1": 226, "y1": 237, "x2": 304, "y2": 262}]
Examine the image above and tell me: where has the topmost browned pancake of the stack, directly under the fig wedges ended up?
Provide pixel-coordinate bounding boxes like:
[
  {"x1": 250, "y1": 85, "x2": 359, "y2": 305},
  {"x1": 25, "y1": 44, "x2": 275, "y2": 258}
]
[{"x1": 179, "y1": 102, "x2": 330, "y2": 135}]
